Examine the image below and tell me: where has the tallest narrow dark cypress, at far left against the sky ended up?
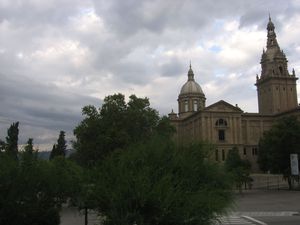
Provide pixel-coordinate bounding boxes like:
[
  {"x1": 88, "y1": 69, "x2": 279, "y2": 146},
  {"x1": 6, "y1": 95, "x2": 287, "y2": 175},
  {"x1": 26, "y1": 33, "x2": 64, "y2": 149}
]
[{"x1": 5, "y1": 122, "x2": 19, "y2": 160}]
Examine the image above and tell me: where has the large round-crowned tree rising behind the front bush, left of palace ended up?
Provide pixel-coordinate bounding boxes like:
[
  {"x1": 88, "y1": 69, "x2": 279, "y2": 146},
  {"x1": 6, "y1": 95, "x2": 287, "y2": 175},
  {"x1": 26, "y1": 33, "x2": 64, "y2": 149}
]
[{"x1": 73, "y1": 94, "x2": 174, "y2": 165}]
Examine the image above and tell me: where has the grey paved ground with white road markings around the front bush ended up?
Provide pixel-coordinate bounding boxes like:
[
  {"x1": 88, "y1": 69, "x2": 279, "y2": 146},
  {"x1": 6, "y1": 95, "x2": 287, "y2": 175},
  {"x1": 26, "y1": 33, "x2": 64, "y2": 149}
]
[{"x1": 61, "y1": 190, "x2": 300, "y2": 225}]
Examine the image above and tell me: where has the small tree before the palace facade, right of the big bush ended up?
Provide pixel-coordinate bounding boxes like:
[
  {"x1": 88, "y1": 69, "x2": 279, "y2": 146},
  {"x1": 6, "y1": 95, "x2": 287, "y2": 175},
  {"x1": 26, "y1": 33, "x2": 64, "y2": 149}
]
[{"x1": 225, "y1": 147, "x2": 252, "y2": 191}]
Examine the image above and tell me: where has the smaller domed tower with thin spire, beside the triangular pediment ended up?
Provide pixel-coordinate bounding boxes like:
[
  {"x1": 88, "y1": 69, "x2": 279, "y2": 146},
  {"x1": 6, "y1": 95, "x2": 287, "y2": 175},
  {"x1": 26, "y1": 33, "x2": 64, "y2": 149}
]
[{"x1": 177, "y1": 64, "x2": 206, "y2": 118}]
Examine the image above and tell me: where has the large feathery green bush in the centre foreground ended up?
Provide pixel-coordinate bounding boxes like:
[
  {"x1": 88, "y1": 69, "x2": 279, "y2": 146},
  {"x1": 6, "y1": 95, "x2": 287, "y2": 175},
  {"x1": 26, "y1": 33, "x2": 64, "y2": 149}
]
[{"x1": 91, "y1": 138, "x2": 232, "y2": 225}]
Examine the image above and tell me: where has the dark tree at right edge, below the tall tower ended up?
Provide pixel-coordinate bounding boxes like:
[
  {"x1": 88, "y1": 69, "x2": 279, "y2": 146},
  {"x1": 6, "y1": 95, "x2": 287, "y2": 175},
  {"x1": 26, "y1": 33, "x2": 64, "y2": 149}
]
[{"x1": 258, "y1": 117, "x2": 300, "y2": 189}]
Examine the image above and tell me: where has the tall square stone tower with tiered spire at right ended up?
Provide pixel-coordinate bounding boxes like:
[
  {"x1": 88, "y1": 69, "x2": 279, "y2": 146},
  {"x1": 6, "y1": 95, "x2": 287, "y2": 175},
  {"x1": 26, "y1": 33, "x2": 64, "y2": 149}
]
[{"x1": 255, "y1": 17, "x2": 298, "y2": 114}]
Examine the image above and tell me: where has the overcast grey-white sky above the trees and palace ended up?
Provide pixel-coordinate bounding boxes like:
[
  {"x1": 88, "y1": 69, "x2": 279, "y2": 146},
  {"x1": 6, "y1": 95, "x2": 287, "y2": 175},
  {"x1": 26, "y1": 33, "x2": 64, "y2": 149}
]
[{"x1": 0, "y1": 0, "x2": 300, "y2": 150}]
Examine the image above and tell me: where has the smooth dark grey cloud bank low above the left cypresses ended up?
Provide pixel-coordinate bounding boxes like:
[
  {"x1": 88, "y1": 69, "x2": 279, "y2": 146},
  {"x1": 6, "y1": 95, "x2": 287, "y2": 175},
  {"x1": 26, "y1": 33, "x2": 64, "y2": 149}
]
[{"x1": 0, "y1": 74, "x2": 101, "y2": 149}]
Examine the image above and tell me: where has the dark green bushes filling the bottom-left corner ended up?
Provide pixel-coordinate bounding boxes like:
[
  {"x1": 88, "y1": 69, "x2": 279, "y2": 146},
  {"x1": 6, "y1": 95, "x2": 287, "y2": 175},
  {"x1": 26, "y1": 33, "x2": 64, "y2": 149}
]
[{"x1": 0, "y1": 152, "x2": 81, "y2": 225}]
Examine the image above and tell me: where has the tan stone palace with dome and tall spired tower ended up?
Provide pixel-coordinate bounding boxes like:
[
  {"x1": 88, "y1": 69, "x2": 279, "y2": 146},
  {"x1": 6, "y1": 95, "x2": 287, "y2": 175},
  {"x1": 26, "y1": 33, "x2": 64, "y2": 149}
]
[{"x1": 169, "y1": 18, "x2": 300, "y2": 172}]
